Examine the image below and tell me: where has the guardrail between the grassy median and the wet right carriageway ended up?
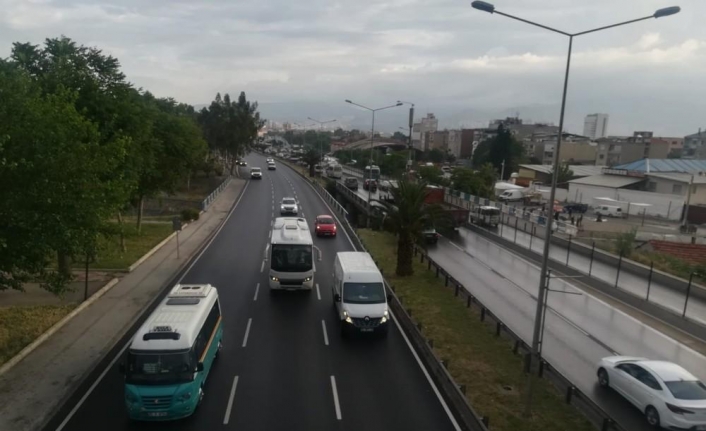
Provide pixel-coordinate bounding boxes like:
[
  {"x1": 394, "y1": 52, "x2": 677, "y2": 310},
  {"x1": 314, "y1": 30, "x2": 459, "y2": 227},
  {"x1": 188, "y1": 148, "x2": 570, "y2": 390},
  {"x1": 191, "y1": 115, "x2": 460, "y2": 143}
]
[{"x1": 414, "y1": 246, "x2": 627, "y2": 431}]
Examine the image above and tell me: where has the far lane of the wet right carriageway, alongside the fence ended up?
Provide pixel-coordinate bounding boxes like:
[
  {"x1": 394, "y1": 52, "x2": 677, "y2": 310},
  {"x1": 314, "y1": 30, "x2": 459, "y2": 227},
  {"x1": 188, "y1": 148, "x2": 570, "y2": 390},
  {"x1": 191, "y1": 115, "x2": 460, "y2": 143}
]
[{"x1": 454, "y1": 229, "x2": 706, "y2": 379}]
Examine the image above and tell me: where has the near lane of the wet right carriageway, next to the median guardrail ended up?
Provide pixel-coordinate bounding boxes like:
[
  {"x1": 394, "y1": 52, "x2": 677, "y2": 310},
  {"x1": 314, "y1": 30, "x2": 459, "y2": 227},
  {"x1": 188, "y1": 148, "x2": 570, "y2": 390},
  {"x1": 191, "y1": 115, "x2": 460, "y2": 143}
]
[{"x1": 429, "y1": 240, "x2": 651, "y2": 431}]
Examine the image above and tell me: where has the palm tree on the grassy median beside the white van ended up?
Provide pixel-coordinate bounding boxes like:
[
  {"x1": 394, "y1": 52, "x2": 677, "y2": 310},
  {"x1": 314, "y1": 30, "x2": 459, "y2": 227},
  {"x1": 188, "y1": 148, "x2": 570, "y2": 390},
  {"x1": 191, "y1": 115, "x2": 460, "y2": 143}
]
[{"x1": 380, "y1": 177, "x2": 442, "y2": 276}]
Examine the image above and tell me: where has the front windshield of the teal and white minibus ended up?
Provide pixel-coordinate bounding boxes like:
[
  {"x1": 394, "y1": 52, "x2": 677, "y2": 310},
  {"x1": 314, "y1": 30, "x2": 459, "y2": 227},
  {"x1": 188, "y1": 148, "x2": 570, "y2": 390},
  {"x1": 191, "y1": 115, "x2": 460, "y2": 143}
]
[{"x1": 125, "y1": 351, "x2": 196, "y2": 385}]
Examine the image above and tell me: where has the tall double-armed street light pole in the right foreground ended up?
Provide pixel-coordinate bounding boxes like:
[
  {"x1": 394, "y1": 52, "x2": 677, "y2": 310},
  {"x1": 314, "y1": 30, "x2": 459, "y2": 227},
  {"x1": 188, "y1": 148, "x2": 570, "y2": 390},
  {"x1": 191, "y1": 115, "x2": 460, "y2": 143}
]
[{"x1": 471, "y1": 0, "x2": 681, "y2": 413}]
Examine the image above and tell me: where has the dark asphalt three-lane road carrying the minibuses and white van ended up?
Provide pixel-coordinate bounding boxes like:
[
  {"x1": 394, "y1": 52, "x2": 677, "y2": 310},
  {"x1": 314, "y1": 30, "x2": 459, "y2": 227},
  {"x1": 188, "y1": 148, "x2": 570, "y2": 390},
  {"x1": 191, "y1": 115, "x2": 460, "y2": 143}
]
[{"x1": 47, "y1": 154, "x2": 458, "y2": 431}]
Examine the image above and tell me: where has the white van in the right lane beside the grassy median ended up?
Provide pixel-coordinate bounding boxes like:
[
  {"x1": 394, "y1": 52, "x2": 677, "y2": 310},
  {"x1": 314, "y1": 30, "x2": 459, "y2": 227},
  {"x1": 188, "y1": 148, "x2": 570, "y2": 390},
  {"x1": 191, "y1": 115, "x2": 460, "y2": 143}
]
[{"x1": 332, "y1": 251, "x2": 390, "y2": 337}]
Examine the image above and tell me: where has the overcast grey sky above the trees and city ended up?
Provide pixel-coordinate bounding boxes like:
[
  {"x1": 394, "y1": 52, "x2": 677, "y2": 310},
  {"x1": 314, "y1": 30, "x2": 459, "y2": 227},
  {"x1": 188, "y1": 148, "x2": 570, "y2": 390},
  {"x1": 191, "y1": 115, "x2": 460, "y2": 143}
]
[{"x1": 0, "y1": 0, "x2": 706, "y2": 136}]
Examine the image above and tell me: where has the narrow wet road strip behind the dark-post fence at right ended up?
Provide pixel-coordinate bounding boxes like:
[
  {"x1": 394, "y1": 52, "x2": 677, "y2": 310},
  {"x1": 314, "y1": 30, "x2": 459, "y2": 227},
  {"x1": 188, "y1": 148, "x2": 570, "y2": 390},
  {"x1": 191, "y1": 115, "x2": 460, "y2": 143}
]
[{"x1": 486, "y1": 221, "x2": 706, "y2": 324}]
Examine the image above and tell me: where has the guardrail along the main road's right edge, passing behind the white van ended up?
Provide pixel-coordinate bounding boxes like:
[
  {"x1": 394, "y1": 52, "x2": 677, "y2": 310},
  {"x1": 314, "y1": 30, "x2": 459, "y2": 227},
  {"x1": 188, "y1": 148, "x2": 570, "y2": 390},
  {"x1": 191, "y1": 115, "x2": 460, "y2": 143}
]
[{"x1": 272, "y1": 155, "x2": 488, "y2": 431}]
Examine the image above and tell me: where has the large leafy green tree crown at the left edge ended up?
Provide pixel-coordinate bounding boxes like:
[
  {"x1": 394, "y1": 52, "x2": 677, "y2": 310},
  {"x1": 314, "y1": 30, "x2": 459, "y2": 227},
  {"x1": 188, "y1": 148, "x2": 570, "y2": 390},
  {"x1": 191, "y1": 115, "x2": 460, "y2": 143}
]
[{"x1": 0, "y1": 62, "x2": 131, "y2": 293}]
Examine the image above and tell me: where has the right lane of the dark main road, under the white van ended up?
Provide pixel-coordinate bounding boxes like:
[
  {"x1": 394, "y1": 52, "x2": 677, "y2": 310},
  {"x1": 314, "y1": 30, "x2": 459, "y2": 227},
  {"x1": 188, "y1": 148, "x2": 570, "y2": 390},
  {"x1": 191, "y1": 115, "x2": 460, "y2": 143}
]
[{"x1": 286, "y1": 161, "x2": 453, "y2": 431}]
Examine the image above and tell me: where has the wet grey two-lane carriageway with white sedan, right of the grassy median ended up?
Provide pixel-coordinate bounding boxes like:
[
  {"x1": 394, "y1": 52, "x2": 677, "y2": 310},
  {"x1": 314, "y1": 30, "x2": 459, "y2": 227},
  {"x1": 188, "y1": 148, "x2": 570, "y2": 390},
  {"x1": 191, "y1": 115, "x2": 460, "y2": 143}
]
[{"x1": 429, "y1": 229, "x2": 706, "y2": 430}]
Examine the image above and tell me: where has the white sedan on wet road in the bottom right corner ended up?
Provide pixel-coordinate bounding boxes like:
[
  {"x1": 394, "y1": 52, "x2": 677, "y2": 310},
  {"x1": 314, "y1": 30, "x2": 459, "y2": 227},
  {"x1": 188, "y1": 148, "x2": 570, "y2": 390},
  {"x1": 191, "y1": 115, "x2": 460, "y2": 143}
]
[{"x1": 598, "y1": 356, "x2": 706, "y2": 430}]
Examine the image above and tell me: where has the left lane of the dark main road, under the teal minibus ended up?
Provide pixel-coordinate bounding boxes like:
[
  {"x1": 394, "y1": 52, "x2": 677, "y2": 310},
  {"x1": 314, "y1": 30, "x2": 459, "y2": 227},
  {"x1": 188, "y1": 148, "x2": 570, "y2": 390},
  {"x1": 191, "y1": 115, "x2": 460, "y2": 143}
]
[{"x1": 54, "y1": 177, "x2": 269, "y2": 431}]
